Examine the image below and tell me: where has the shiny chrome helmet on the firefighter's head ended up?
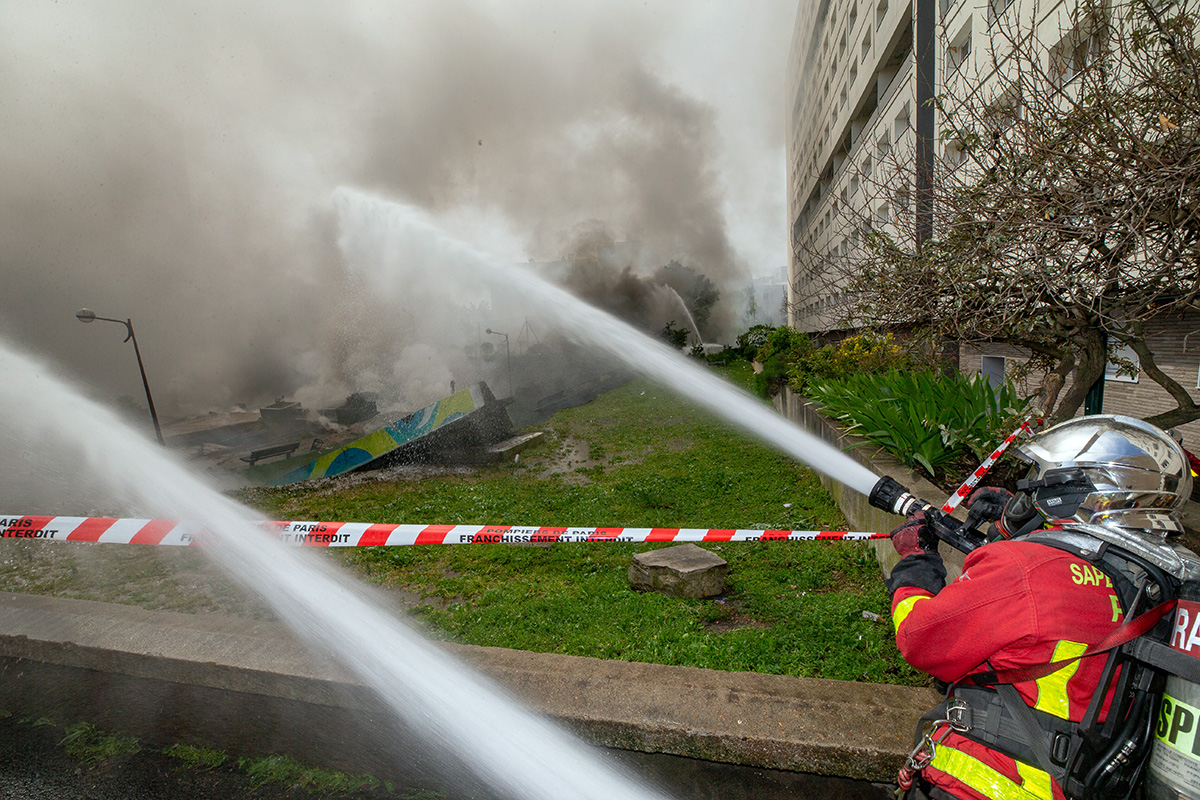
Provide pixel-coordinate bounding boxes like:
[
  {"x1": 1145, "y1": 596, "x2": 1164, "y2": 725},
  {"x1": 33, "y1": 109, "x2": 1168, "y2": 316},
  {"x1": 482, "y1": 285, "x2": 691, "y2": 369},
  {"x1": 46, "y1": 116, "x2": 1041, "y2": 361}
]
[{"x1": 1006, "y1": 414, "x2": 1192, "y2": 534}]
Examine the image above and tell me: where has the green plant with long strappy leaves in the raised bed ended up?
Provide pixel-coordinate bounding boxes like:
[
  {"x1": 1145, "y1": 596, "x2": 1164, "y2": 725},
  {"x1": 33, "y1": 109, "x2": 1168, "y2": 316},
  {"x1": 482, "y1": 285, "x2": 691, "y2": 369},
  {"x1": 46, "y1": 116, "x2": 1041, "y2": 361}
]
[{"x1": 808, "y1": 371, "x2": 1025, "y2": 480}]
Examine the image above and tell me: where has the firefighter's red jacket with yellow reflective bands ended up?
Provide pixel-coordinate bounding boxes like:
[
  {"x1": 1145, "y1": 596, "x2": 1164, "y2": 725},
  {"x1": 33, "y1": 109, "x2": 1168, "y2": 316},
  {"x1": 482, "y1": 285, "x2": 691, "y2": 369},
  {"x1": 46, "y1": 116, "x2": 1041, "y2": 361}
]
[{"x1": 888, "y1": 540, "x2": 1124, "y2": 800}]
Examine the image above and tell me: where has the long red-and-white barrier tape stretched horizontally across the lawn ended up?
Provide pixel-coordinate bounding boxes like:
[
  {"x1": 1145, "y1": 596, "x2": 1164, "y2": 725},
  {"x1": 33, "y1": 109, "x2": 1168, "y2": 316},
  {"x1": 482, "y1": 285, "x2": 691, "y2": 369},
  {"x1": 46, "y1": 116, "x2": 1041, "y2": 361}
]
[{"x1": 0, "y1": 515, "x2": 890, "y2": 547}]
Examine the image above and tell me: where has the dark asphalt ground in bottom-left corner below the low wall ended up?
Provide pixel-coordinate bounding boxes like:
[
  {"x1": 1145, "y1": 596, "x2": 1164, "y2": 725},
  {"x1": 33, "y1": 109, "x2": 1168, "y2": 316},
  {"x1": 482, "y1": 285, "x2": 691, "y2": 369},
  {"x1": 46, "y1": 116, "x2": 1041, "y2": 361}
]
[{"x1": 0, "y1": 716, "x2": 410, "y2": 800}]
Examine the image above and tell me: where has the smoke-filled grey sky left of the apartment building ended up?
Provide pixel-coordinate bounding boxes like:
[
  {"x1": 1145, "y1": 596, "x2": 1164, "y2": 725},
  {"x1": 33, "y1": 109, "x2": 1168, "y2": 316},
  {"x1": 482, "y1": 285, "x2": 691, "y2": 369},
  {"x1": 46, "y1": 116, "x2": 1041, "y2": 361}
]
[{"x1": 0, "y1": 0, "x2": 796, "y2": 416}]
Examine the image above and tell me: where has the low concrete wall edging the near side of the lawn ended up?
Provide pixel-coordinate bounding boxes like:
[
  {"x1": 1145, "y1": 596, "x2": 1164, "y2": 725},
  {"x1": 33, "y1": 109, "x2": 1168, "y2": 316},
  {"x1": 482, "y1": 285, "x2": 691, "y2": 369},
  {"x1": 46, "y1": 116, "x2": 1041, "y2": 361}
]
[{"x1": 0, "y1": 594, "x2": 938, "y2": 796}]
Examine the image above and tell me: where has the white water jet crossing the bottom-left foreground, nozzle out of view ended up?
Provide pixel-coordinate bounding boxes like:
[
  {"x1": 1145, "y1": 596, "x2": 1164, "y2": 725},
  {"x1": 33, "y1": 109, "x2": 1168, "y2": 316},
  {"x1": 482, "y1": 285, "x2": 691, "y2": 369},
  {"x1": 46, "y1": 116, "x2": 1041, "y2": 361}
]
[{"x1": 0, "y1": 342, "x2": 665, "y2": 800}]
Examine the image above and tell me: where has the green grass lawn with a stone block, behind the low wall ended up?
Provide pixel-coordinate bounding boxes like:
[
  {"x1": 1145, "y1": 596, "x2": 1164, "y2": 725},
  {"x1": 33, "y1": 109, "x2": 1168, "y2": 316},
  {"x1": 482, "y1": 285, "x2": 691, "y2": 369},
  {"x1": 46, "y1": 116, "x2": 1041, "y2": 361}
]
[{"x1": 242, "y1": 363, "x2": 924, "y2": 684}]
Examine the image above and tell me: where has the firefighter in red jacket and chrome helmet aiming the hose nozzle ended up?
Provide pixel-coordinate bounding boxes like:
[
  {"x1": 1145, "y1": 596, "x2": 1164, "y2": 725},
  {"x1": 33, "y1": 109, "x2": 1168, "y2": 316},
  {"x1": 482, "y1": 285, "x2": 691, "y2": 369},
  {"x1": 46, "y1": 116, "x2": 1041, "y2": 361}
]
[{"x1": 888, "y1": 415, "x2": 1192, "y2": 800}]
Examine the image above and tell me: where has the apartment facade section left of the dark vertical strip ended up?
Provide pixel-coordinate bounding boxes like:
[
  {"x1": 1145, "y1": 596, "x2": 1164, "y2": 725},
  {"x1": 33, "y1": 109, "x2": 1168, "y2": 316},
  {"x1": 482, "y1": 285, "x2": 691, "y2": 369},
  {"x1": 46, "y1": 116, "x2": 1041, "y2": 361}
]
[{"x1": 787, "y1": 0, "x2": 916, "y2": 331}]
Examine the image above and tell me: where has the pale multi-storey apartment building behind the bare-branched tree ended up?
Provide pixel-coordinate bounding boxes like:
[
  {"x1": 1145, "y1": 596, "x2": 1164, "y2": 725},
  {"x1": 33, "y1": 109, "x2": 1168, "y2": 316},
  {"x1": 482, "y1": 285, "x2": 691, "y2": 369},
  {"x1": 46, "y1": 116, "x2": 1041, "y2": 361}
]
[{"x1": 786, "y1": 0, "x2": 1200, "y2": 450}]
